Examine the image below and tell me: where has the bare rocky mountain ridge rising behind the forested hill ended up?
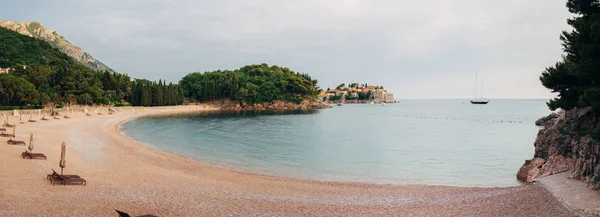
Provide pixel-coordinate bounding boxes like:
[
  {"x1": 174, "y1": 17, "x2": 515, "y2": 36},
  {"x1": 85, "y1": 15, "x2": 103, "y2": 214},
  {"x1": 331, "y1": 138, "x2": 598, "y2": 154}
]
[{"x1": 0, "y1": 21, "x2": 115, "y2": 72}]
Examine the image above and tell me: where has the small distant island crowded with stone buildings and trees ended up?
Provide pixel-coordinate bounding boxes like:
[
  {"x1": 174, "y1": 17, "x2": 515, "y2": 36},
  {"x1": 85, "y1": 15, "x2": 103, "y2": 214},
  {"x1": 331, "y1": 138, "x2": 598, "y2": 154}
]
[{"x1": 319, "y1": 83, "x2": 396, "y2": 104}]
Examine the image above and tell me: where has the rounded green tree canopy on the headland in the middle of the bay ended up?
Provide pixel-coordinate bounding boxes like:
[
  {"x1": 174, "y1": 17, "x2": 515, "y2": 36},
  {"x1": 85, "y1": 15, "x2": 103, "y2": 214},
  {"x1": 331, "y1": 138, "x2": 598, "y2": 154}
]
[{"x1": 179, "y1": 64, "x2": 318, "y2": 104}]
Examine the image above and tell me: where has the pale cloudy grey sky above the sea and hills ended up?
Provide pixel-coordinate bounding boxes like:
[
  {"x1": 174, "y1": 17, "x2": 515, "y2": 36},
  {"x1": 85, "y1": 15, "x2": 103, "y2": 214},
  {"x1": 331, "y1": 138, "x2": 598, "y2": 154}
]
[{"x1": 0, "y1": 0, "x2": 572, "y2": 99}]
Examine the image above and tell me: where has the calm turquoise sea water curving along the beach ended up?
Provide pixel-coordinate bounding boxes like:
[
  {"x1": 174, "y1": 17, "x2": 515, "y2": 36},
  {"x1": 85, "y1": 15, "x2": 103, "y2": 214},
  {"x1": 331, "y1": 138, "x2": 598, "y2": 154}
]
[{"x1": 121, "y1": 100, "x2": 550, "y2": 187}]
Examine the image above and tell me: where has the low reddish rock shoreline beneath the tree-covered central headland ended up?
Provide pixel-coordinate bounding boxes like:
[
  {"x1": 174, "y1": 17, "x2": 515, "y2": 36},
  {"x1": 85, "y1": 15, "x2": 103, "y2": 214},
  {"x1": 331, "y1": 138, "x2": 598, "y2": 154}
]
[{"x1": 208, "y1": 99, "x2": 331, "y2": 111}]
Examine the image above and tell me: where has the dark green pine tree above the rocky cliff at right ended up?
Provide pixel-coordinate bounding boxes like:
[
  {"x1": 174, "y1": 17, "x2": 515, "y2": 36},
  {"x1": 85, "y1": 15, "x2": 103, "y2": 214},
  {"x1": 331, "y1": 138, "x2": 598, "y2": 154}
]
[{"x1": 540, "y1": 0, "x2": 600, "y2": 110}]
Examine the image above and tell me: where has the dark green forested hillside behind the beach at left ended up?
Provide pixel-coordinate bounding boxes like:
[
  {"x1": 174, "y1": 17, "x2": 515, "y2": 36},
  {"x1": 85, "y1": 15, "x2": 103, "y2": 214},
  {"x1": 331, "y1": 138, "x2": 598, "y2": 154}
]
[{"x1": 0, "y1": 28, "x2": 183, "y2": 106}]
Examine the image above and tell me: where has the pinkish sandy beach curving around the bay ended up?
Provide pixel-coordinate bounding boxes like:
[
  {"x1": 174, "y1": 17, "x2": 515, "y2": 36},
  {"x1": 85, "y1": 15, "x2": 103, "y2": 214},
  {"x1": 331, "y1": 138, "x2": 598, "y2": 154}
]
[{"x1": 0, "y1": 106, "x2": 572, "y2": 216}]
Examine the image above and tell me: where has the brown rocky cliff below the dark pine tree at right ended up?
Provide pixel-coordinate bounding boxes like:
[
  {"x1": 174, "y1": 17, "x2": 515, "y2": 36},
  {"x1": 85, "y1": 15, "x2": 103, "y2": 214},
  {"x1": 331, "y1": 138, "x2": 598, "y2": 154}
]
[{"x1": 517, "y1": 108, "x2": 600, "y2": 190}]
